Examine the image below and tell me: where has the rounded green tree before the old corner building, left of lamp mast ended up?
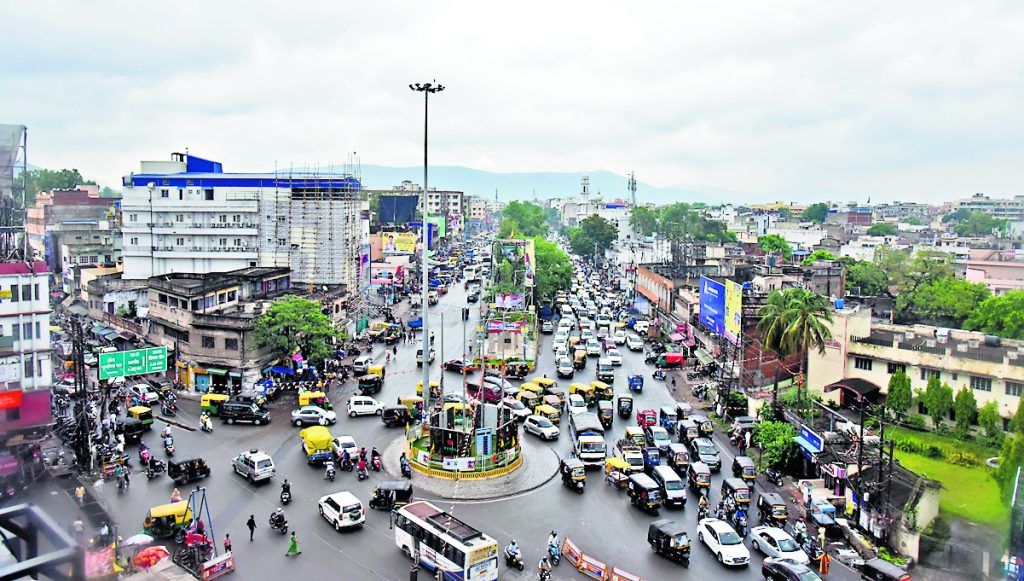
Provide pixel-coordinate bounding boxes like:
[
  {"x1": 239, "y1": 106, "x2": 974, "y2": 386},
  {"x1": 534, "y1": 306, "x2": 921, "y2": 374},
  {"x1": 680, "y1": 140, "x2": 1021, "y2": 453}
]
[{"x1": 253, "y1": 296, "x2": 339, "y2": 365}]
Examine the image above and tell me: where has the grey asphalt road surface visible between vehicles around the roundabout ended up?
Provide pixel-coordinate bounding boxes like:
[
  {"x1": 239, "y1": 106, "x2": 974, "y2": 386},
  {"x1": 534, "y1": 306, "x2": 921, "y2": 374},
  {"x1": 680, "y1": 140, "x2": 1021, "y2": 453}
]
[{"x1": 94, "y1": 278, "x2": 849, "y2": 579}]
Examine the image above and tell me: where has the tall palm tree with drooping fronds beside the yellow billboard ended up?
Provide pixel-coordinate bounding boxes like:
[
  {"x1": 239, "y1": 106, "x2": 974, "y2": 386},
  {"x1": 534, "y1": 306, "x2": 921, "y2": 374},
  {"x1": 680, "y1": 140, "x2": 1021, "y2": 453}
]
[{"x1": 758, "y1": 288, "x2": 833, "y2": 401}]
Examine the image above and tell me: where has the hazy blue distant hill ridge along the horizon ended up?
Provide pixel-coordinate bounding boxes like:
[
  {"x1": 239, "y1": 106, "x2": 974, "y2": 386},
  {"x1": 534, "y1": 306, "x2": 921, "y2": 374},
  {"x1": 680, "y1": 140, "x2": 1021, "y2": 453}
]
[{"x1": 361, "y1": 165, "x2": 721, "y2": 203}]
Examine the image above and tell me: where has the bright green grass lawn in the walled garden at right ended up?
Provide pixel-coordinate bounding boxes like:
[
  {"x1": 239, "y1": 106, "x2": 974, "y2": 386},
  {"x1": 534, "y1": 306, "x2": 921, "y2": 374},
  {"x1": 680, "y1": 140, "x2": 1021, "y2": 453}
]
[{"x1": 895, "y1": 450, "x2": 1010, "y2": 531}]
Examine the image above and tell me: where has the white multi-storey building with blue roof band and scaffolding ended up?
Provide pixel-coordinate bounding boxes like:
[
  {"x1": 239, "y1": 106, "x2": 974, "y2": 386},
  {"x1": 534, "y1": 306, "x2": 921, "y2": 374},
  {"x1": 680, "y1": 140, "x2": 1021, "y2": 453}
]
[{"x1": 122, "y1": 154, "x2": 369, "y2": 289}]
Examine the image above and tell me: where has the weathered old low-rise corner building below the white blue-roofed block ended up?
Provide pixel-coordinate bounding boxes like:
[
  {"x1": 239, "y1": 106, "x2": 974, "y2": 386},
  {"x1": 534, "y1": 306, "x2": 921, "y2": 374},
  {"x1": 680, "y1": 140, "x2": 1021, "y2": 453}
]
[{"x1": 146, "y1": 266, "x2": 291, "y2": 392}]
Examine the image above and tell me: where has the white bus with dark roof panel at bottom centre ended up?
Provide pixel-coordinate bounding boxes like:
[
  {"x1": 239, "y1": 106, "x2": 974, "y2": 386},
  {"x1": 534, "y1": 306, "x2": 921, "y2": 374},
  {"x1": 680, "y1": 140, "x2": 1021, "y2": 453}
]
[{"x1": 394, "y1": 501, "x2": 498, "y2": 581}]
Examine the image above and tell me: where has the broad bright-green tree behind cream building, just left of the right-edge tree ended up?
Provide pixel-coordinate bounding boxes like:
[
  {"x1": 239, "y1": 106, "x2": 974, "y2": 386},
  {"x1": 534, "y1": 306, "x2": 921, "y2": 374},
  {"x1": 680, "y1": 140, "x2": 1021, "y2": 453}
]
[{"x1": 896, "y1": 277, "x2": 989, "y2": 329}]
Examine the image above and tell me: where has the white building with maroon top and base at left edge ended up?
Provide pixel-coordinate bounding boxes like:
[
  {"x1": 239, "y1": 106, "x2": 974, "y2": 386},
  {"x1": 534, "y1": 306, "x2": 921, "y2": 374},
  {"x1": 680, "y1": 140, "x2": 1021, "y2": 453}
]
[{"x1": 0, "y1": 260, "x2": 53, "y2": 436}]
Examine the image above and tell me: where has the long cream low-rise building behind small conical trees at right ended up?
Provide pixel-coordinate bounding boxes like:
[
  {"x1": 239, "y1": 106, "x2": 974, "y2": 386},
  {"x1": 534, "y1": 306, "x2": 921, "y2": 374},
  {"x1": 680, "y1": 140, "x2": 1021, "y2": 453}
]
[{"x1": 807, "y1": 305, "x2": 1024, "y2": 421}]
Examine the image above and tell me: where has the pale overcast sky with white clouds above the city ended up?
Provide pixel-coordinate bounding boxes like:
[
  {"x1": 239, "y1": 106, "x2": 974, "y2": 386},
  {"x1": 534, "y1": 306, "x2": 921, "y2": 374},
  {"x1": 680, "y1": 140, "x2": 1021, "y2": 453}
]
[{"x1": 0, "y1": 0, "x2": 1024, "y2": 202}]
